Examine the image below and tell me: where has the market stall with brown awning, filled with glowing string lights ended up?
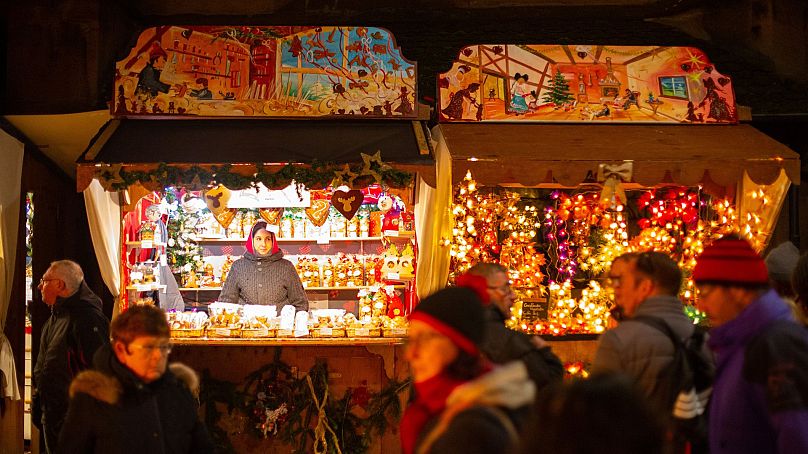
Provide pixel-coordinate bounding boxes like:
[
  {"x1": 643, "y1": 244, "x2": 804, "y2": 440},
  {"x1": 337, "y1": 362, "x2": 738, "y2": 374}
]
[{"x1": 424, "y1": 44, "x2": 800, "y2": 370}]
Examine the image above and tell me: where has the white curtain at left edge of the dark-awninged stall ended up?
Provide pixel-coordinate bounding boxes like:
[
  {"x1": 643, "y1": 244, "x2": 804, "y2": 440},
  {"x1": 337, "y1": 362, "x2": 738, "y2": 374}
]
[{"x1": 84, "y1": 180, "x2": 121, "y2": 318}]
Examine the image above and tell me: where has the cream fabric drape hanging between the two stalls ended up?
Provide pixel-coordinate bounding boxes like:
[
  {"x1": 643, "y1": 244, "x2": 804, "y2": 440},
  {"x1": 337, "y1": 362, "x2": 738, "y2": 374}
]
[{"x1": 415, "y1": 126, "x2": 453, "y2": 298}]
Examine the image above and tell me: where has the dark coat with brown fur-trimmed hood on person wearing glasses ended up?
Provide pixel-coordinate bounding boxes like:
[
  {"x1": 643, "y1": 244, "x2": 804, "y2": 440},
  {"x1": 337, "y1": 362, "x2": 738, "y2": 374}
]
[{"x1": 57, "y1": 346, "x2": 214, "y2": 454}]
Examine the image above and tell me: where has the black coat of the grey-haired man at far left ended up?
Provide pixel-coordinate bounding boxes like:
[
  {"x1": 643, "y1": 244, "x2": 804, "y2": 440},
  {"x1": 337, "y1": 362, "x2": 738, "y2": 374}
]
[{"x1": 32, "y1": 281, "x2": 109, "y2": 426}]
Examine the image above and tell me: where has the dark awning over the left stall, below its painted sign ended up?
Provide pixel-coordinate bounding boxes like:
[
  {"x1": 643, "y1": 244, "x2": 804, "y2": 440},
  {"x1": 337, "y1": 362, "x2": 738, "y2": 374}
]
[{"x1": 77, "y1": 119, "x2": 435, "y2": 190}]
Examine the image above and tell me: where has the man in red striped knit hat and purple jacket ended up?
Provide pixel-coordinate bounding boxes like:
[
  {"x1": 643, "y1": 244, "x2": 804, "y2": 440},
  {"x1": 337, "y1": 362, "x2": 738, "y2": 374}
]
[{"x1": 693, "y1": 236, "x2": 808, "y2": 454}]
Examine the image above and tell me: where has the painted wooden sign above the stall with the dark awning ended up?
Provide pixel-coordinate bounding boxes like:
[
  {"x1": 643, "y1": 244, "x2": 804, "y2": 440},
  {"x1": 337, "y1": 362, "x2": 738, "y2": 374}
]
[{"x1": 112, "y1": 26, "x2": 417, "y2": 118}]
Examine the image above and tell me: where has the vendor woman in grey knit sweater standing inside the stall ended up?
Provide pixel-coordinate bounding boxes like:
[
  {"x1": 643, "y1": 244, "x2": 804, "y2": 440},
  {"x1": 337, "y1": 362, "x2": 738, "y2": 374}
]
[{"x1": 219, "y1": 221, "x2": 309, "y2": 311}]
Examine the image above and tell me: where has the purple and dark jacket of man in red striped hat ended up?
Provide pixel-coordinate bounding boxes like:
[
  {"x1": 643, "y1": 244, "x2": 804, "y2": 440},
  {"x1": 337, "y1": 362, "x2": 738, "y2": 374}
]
[{"x1": 709, "y1": 290, "x2": 808, "y2": 454}]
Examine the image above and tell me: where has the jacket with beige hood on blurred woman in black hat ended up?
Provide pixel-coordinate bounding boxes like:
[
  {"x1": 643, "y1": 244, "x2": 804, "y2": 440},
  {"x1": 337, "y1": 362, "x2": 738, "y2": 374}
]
[{"x1": 415, "y1": 361, "x2": 536, "y2": 454}]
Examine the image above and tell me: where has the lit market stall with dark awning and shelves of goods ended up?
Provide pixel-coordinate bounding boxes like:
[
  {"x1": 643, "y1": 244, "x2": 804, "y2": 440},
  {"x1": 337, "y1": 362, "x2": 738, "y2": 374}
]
[{"x1": 77, "y1": 26, "x2": 434, "y2": 452}]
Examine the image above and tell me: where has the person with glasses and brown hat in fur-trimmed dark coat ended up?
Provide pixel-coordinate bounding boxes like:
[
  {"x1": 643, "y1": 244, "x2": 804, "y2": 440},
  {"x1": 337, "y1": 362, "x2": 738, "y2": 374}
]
[{"x1": 59, "y1": 306, "x2": 214, "y2": 454}]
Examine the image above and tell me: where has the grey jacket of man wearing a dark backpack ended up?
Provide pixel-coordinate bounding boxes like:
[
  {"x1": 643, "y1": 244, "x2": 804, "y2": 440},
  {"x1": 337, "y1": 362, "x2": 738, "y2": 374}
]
[{"x1": 592, "y1": 296, "x2": 712, "y2": 408}]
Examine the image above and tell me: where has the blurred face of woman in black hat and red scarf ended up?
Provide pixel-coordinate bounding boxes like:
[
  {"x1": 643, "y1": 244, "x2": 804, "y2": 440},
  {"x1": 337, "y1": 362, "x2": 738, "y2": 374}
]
[{"x1": 404, "y1": 320, "x2": 459, "y2": 383}]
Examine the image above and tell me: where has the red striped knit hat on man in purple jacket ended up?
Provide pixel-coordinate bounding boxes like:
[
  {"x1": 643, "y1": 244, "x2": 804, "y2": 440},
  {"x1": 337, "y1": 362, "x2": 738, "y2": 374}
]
[{"x1": 693, "y1": 237, "x2": 769, "y2": 284}]
